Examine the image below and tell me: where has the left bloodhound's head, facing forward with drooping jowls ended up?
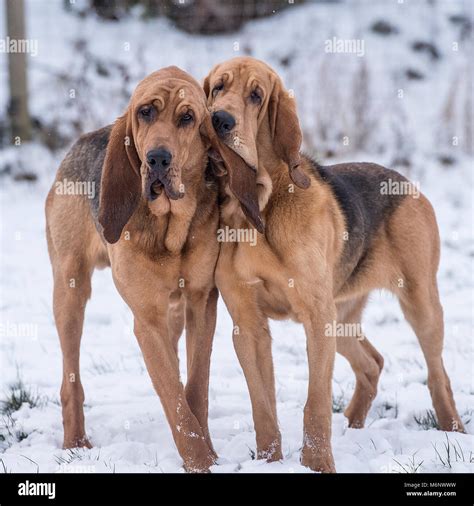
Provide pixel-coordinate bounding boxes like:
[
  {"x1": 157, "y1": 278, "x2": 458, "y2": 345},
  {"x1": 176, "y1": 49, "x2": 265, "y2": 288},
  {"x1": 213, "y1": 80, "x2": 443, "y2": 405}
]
[{"x1": 99, "y1": 67, "x2": 220, "y2": 243}]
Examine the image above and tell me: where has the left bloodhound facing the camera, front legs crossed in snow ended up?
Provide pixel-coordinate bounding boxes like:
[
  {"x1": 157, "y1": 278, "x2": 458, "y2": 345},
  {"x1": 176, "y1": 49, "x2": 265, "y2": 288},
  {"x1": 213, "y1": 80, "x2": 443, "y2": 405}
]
[{"x1": 46, "y1": 67, "x2": 233, "y2": 471}]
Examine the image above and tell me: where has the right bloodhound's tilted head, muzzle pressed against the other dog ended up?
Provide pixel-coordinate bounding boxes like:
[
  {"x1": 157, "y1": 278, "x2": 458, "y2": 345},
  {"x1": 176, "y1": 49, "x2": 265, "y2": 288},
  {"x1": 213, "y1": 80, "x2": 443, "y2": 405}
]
[{"x1": 204, "y1": 57, "x2": 310, "y2": 193}]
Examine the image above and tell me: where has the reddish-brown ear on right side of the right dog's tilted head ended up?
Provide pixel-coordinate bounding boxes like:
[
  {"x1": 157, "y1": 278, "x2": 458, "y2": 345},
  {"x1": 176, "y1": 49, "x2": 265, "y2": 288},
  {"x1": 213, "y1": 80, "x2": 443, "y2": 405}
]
[{"x1": 268, "y1": 78, "x2": 311, "y2": 188}]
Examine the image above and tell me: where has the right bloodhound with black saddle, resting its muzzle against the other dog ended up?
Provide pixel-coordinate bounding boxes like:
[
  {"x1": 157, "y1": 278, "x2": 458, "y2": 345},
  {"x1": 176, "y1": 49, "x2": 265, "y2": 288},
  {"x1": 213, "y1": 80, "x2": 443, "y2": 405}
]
[{"x1": 204, "y1": 57, "x2": 463, "y2": 472}]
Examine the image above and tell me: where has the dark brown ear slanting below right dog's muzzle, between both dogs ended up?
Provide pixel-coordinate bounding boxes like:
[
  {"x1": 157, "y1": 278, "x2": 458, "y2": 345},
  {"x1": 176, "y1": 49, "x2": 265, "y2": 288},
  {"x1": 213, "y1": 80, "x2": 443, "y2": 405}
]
[{"x1": 201, "y1": 114, "x2": 265, "y2": 234}]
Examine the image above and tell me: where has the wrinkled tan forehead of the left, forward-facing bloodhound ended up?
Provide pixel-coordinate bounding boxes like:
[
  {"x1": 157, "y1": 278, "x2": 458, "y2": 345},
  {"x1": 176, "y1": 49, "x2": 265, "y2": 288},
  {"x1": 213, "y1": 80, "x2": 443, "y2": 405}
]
[{"x1": 132, "y1": 75, "x2": 206, "y2": 112}]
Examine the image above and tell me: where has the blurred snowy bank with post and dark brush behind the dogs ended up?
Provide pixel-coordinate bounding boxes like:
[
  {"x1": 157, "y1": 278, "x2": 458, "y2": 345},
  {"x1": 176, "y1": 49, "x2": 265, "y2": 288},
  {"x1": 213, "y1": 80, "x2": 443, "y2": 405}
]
[{"x1": 0, "y1": 0, "x2": 473, "y2": 180}]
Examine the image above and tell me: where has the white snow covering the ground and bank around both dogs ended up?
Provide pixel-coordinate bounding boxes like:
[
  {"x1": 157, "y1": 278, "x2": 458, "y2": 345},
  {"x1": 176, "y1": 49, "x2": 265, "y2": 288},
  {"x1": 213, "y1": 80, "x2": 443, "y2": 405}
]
[{"x1": 0, "y1": 0, "x2": 474, "y2": 472}]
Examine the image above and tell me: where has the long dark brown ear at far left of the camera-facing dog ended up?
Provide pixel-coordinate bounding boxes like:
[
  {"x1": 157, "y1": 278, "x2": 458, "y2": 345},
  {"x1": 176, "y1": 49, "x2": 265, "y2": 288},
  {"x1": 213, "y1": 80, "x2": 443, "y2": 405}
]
[{"x1": 99, "y1": 112, "x2": 141, "y2": 244}]
